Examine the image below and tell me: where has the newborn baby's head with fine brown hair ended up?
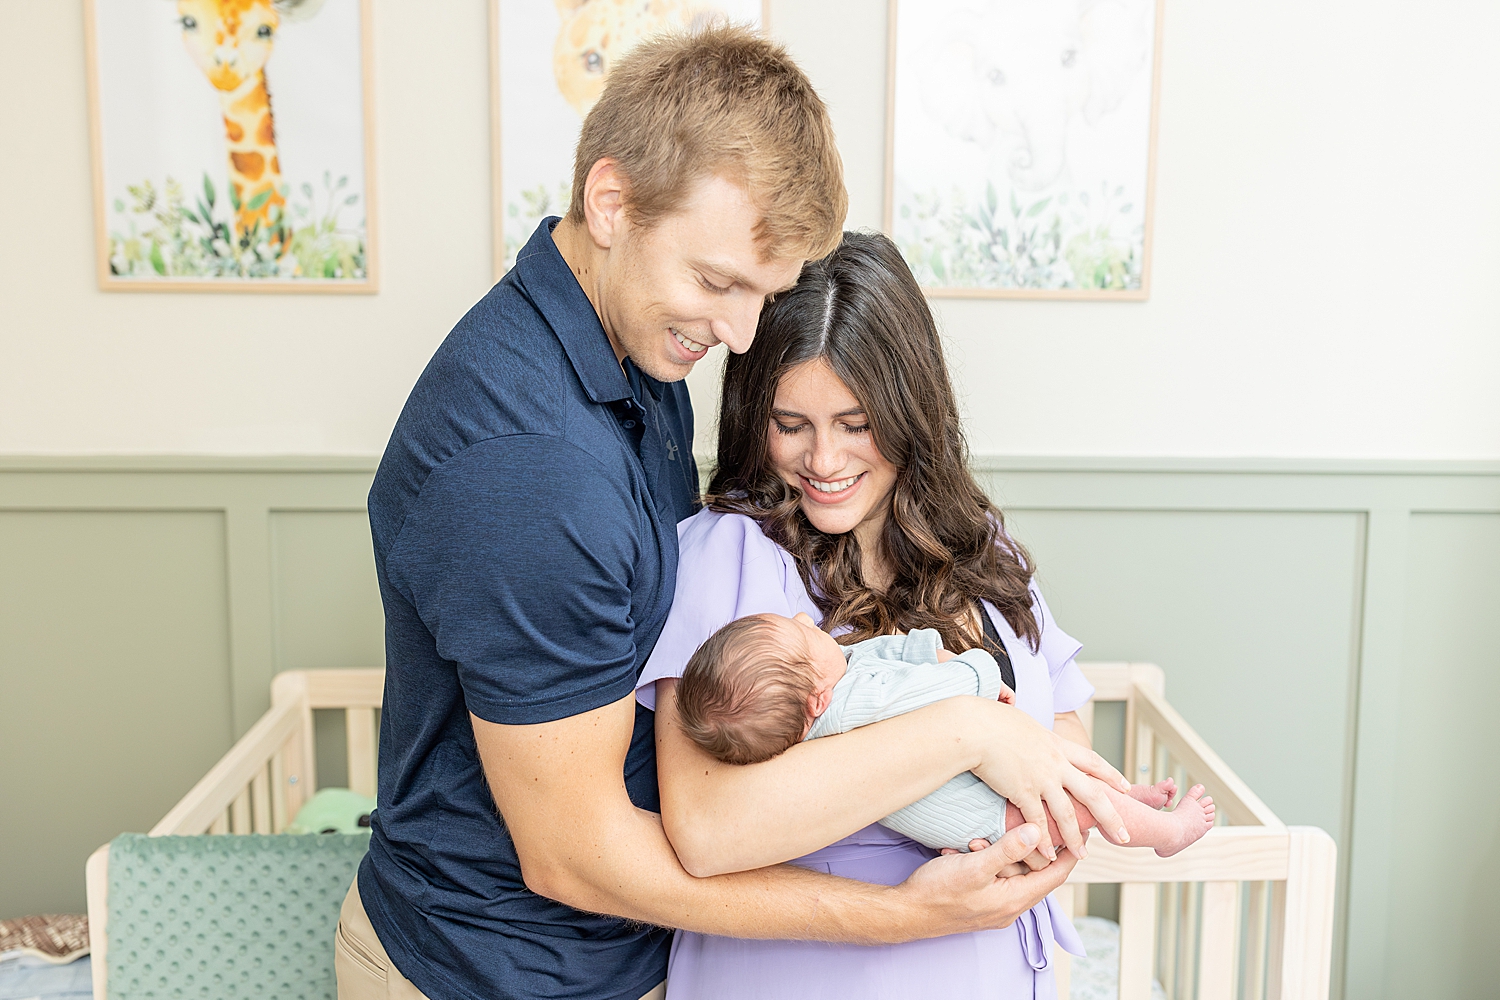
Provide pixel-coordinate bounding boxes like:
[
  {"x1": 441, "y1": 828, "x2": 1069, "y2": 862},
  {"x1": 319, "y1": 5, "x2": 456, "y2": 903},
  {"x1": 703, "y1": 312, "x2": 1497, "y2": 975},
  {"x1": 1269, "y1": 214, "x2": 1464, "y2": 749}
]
[{"x1": 677, "y1": 615, "x2": 849, "y2": 765}]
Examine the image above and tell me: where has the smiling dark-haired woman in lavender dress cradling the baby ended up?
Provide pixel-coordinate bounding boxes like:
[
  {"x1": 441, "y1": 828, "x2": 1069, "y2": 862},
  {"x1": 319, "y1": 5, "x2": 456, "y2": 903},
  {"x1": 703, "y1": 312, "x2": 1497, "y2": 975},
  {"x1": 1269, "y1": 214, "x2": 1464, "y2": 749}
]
[{"x1": 638, "y1": 234, "x2": 1118, "y2": 1000}]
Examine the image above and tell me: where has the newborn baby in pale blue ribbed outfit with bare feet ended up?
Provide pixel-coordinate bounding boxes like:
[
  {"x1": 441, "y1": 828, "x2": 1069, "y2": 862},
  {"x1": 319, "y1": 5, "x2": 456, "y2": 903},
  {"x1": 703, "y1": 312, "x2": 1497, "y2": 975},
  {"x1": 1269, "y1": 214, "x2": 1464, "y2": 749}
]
[{"x1": 677, "y1": 615, "x2": 1214, "y2": 858}]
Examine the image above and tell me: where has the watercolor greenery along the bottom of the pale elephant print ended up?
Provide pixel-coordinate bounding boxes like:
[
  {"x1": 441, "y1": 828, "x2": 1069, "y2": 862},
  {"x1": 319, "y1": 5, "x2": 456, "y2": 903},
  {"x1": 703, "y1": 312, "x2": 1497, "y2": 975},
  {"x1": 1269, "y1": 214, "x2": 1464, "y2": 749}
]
[{"x1": 896, "y1": 183, "x2": 1143, "y2": 291}]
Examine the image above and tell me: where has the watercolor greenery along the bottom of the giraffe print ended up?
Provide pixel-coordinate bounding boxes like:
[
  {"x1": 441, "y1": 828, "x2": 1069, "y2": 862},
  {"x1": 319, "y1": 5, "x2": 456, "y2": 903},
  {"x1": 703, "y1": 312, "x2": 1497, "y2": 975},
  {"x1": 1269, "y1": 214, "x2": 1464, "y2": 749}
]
[{"x1": 110, "y1": 171, "x2": 366, "y2": 280}]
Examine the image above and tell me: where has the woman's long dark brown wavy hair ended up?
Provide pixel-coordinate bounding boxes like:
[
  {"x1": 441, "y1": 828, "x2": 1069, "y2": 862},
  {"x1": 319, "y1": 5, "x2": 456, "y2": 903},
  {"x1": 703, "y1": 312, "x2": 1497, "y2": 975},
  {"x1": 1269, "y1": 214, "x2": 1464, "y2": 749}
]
[{"x1": 704, "y1": 232, "x2": 1041, "y2": 651}]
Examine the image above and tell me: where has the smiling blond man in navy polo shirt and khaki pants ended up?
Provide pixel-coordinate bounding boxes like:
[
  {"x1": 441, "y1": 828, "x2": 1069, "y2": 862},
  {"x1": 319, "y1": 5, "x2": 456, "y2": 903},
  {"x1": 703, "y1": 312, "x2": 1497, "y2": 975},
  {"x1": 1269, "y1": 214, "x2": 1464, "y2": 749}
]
[{"x1": 336, "y1": 27, "x2": 1104, "y2": 1000}]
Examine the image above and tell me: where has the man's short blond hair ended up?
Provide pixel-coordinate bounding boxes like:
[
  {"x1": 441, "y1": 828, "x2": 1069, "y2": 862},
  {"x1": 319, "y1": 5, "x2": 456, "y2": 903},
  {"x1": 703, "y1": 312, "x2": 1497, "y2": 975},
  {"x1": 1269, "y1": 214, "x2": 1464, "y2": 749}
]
[{"x1": 569, "y1": 24, "x2": 849, "y2": 259}]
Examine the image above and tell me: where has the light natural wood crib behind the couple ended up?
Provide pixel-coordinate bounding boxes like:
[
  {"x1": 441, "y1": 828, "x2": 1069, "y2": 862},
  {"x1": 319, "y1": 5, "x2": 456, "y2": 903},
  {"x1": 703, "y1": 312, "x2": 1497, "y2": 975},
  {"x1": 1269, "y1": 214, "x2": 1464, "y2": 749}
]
[{"x1": 87, "y1": 663, "x2": 1335, "y2": 1000}]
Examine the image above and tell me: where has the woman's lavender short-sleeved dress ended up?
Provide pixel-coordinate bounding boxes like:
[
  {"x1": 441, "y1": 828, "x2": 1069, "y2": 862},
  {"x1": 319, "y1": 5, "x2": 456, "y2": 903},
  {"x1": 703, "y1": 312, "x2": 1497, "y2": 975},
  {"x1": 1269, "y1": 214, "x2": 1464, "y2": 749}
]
[{"x1": 636, "y1": 510, "x2": 1094, "y2": 1000}]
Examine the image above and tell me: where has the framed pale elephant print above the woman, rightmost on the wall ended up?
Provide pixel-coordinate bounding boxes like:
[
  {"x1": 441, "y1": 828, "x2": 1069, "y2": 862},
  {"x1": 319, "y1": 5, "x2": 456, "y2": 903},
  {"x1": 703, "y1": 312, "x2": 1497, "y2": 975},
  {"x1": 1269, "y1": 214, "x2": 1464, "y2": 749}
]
[{"x1": 885, "y1": 0, "x2": 1163, "y2": 300}]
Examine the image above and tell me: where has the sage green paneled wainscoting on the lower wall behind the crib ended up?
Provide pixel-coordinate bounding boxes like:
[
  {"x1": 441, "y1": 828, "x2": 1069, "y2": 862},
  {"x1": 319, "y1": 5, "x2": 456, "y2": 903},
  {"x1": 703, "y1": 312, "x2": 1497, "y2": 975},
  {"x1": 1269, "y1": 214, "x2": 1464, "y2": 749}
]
[{"x1": 0, "y1": 457, "x2": 1500, "y2": 1000}]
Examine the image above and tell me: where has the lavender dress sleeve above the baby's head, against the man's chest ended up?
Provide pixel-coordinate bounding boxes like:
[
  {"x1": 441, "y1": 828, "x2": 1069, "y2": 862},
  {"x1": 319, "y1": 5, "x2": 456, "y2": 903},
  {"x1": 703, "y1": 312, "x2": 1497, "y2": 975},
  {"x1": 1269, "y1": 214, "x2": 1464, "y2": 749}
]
[{"x1": 636, "y1": 510, "x2": 822, "y2": 711}]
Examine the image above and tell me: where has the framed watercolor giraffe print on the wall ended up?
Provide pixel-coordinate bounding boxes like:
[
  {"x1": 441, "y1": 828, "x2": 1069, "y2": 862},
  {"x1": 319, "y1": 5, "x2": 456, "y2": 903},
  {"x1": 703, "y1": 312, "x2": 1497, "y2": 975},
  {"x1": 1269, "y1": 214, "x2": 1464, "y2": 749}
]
[{"x1": 84, "y1": 0, "x2": 377, "y2": 292}]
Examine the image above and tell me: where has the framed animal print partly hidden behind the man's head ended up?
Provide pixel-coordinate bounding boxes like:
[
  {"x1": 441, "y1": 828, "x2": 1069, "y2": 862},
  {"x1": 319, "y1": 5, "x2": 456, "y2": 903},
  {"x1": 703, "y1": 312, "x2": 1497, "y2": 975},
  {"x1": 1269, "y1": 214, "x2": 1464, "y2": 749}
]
[{"x1": 491, "y1": 0, "x2": 770, "y2": 280}]
